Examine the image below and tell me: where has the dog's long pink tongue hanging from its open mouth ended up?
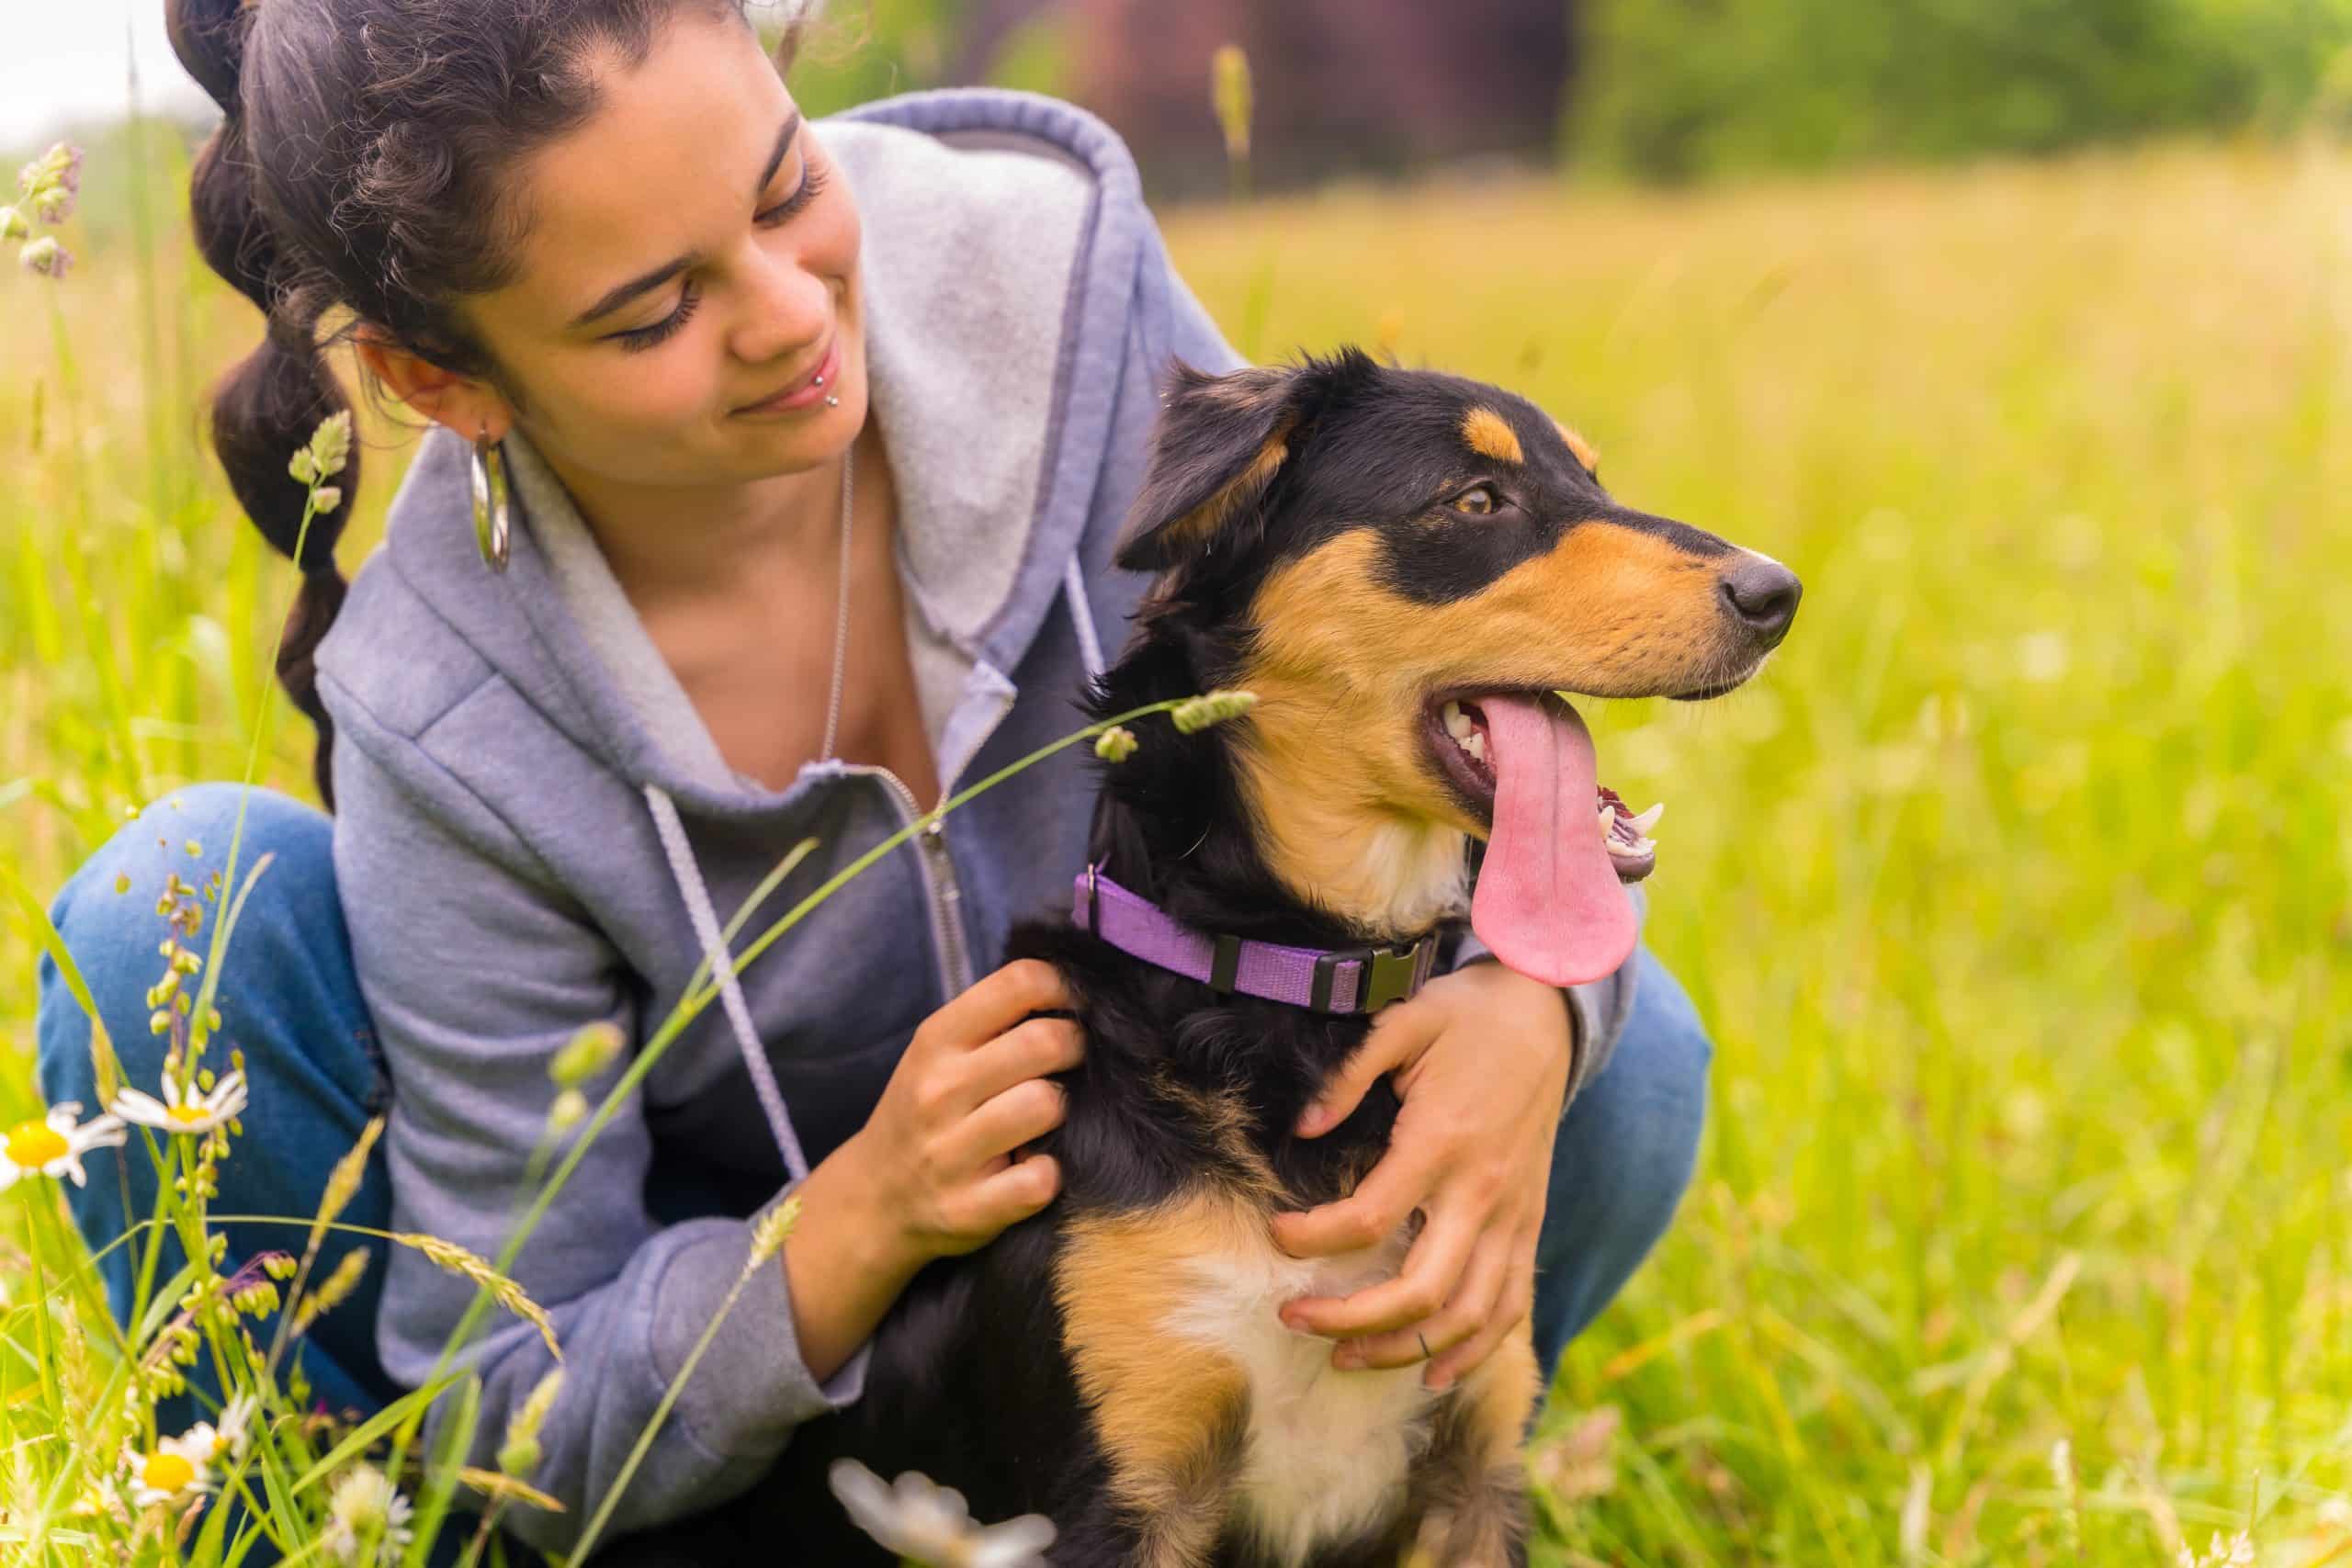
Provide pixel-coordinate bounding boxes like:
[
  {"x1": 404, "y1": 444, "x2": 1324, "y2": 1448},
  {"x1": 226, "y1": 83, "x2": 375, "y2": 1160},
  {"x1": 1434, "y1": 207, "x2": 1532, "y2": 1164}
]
[{"x1": 1470, "y1": 696, "x2": 1639, "y2": 985}]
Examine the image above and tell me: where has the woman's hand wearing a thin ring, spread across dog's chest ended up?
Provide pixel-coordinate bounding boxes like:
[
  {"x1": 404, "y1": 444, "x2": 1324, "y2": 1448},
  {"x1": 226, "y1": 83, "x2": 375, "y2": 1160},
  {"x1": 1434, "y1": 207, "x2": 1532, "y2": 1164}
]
[{"x1": 1275, "y1": 964, "x2": 1574, "y2": 1389}]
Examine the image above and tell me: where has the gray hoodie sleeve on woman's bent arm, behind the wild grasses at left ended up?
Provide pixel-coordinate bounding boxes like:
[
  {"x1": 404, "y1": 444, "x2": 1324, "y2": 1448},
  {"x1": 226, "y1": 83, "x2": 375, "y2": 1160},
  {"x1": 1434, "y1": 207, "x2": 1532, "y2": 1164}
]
[{"x1": 334, "y1": 719, "x2": 864, "y2": 1550}]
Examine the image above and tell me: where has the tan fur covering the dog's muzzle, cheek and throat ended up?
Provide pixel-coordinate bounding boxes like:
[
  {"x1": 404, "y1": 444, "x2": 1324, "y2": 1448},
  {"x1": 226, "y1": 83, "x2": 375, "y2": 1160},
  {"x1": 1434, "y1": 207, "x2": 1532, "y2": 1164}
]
[{"x1": 1235, "y1": 522, "x2": 1740, "y2": 929}]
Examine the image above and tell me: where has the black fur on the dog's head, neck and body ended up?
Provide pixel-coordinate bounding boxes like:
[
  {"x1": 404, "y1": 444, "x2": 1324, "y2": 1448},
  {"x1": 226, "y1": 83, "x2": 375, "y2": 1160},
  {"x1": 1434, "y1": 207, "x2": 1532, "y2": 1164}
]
[{"x1": 597, "y1": 353, "x2": 1787, "y2": 1568}]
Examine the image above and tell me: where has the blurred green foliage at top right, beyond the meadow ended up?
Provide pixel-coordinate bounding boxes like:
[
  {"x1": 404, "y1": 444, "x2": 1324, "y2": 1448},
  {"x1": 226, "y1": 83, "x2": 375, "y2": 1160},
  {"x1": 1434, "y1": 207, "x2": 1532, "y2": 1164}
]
[{"x1": 1571, "y1": 0, "x2": 2352, "y2": 179}]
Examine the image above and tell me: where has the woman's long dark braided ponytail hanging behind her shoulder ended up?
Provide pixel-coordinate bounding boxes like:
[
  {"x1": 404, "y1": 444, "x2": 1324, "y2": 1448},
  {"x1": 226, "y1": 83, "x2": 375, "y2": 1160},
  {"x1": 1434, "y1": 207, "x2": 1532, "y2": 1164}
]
[{"x1": 167, "y1": 0, "x2": 360, "y2": 811}]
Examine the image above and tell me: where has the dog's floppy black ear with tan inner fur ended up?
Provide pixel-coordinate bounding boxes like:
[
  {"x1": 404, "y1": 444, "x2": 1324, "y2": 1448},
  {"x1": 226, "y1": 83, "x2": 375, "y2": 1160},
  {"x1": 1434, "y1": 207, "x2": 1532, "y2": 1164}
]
[{"x1": 1120, "y1": 362, "x2": 1315, "y2": 571}]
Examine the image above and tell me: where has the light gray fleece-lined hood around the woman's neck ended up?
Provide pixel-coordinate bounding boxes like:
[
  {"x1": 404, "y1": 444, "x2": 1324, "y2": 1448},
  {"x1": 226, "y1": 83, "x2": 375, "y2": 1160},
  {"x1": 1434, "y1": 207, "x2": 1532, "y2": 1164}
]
[{"x1": 343, "y1": 92, "x2": 1141, "y2": 813}]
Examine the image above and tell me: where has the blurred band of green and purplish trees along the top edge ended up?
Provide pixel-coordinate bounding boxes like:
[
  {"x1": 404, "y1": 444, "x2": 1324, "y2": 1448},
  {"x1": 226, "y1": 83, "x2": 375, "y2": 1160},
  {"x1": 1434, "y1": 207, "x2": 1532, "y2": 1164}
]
[{"x1": 771, "y1": 0, "x2": 2352, "y2": 195}]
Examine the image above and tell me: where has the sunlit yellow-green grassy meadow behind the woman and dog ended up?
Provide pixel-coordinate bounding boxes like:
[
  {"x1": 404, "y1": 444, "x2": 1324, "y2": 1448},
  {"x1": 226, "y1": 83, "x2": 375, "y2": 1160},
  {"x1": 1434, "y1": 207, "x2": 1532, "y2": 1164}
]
[{"x1": 0, "y1": 125, "x2": 2352, "y2": 1568}]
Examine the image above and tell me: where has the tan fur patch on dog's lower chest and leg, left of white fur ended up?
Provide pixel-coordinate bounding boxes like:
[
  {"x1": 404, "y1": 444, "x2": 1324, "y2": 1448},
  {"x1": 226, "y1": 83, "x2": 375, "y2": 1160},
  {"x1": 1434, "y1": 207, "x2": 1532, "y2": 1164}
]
[{"x1": 1054, "y1": 1197, "x2": 1263, "y2": 1568}]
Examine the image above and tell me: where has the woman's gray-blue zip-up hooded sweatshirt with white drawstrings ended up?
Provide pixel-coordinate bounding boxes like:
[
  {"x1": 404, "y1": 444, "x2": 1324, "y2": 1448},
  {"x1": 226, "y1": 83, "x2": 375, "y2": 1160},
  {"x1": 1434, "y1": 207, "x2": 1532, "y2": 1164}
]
[{"x1": 320, "y1": 92, "x2": 1630, "y2": 1550}]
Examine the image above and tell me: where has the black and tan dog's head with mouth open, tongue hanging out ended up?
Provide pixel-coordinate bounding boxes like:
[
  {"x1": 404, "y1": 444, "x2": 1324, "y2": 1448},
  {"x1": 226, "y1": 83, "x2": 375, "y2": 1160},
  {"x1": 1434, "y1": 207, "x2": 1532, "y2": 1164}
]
[{"x1": 1120, "y1": 350, "x2": 1799, "y2": 985}]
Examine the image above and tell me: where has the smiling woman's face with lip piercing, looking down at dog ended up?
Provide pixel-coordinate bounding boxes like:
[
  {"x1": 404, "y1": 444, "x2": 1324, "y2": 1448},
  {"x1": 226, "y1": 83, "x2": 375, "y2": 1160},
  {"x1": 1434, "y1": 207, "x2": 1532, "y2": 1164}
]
[{"x1": 444, "y1": 12, "x2": 865, "y2": 487}]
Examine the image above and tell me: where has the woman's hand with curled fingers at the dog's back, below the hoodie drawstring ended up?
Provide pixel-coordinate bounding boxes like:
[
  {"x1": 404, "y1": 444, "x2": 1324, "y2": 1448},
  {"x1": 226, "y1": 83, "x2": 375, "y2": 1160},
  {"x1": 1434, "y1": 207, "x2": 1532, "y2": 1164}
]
[{"x1": 783, "y1": 959, "x2": 1084, "y2": 1378}]
